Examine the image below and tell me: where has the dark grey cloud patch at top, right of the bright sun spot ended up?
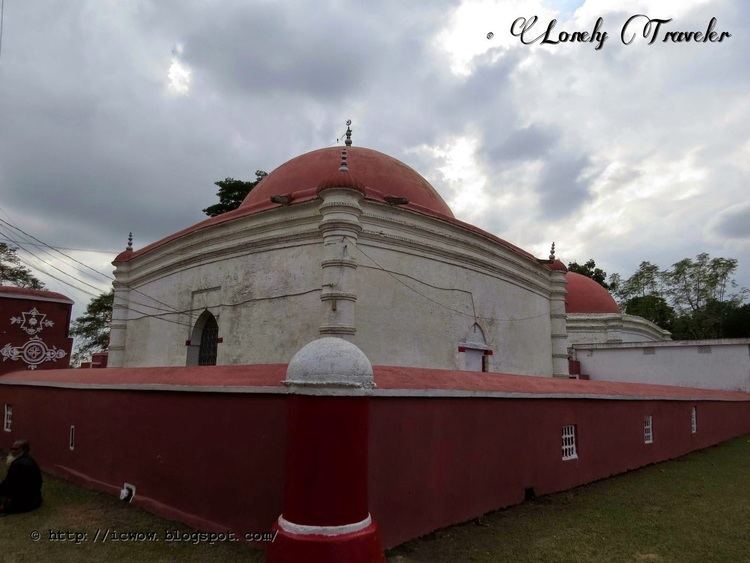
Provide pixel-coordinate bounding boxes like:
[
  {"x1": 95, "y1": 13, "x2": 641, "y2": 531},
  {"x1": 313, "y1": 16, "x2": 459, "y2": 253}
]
[{"x1": 184, "y1": 3, "x2": 371, "y2": 101}]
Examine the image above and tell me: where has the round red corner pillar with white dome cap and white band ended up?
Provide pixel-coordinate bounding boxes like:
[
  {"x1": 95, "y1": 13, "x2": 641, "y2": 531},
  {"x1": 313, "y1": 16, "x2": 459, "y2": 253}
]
[{"x1": 268, "y1": 338, "x2": 385, "y2": 563}]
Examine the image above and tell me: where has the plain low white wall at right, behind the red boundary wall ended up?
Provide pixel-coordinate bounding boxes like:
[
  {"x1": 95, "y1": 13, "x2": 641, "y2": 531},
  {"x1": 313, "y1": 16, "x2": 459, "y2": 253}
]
[{"x1": 574, "y1": 338, "x2": 750, "y2": 391}]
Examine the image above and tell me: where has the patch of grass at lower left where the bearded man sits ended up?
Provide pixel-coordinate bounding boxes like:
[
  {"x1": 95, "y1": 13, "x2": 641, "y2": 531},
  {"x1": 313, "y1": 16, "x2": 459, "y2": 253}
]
[{"x1": 0, "y1": 463, "x2": 263, "y2": 563}]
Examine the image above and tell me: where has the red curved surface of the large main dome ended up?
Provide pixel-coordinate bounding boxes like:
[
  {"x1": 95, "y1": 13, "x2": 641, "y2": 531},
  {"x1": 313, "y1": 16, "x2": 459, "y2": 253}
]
[{"x1": 240, "y1": 146, "x2": 453, "y2": 218}]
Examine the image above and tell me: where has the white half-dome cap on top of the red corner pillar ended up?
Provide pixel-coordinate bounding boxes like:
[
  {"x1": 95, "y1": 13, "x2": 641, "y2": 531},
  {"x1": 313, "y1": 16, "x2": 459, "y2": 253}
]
[{"x1": 284, "y1": 336, "x2": 375, "y2": 389}]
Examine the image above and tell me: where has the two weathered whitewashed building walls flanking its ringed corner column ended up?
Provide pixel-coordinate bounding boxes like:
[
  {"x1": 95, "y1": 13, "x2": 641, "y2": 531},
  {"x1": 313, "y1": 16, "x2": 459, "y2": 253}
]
[{"x1": 117, "y1": 198, "x2": 552, "y2": 375}]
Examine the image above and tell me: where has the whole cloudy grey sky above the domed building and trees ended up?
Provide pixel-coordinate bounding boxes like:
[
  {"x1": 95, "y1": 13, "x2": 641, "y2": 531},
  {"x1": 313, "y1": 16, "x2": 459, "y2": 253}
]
[{"x1": 0, "y1": 0, "x2": 750, "y2": 313}]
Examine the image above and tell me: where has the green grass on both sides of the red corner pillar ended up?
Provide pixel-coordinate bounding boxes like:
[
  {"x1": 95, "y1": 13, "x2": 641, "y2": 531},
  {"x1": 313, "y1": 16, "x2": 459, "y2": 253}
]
[{"x1": 0, "y1": 435, "x2": 750, "y2": 563}]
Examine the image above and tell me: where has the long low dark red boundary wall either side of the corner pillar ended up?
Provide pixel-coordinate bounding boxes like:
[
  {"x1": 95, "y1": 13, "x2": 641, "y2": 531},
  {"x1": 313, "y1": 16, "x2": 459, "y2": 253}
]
[{"x1": 0, "y1": 365, "x2": 750, "y2": 547}]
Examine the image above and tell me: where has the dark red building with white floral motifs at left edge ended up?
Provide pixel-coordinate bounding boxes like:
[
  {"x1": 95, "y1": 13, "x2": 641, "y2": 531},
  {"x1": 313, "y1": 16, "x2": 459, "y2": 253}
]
[{"x1": 0, "y1": 286, "x2": 73, "y2": 374}]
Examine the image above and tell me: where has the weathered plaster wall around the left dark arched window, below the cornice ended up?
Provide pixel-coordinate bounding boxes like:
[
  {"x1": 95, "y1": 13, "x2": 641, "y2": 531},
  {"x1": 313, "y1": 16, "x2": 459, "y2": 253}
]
[{"x1": 125, "y1": 245, "x2": 321, "y2": 367}]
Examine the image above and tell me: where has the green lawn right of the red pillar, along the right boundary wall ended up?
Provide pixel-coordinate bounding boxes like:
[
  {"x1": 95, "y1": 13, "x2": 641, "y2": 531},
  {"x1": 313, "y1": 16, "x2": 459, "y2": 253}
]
[{"x1": 387, "y1": 435, "x2": 750, "y2": 563}]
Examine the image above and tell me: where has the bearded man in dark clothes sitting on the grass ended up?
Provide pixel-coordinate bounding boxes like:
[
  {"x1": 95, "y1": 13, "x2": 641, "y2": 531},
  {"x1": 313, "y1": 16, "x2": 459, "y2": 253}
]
[{"x1": 0, "y1": 440, "x2": 42, "y2": 514}]
